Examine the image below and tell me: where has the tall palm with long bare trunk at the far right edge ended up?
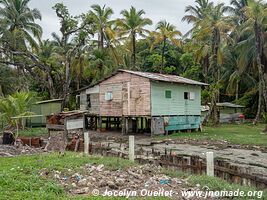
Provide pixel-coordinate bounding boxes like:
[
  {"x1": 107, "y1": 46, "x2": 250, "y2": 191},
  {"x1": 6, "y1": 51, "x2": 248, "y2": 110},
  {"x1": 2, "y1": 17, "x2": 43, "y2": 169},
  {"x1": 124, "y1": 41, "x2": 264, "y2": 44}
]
[{"x1": 242, "y1": 0, "x2": 267, "y2": 124}]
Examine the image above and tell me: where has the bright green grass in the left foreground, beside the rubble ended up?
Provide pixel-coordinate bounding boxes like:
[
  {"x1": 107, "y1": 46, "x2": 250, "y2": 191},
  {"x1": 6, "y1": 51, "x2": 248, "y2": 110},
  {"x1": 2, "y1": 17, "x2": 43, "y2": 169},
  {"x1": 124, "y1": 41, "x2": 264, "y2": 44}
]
[{"x1": 0, "y1": 152, "x2": 134, "y2": 199}]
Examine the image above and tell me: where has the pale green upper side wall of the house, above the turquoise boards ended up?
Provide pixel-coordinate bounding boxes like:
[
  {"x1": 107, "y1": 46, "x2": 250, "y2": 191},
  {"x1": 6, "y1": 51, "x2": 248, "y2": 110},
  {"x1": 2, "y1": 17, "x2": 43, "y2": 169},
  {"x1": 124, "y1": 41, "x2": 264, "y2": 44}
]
[{"x1": 151, "y1": 82, "x2": 201, "y2": 116}]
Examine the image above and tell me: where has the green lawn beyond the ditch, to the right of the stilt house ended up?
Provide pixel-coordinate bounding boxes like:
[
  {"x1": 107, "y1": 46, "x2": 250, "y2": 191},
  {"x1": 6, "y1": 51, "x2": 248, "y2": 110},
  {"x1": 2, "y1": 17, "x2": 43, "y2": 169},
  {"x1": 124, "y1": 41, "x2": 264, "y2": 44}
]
[{"x1": 156, "y1": 124, "x2": 267, "y2": 147}]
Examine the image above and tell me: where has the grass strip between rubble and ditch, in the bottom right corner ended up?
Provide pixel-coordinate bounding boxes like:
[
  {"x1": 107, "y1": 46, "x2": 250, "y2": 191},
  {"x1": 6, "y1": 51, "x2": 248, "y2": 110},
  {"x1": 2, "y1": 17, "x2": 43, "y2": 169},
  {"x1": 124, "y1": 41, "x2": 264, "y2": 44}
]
[{"x1": 162, "y1": 169, "x2": 267, "y2": 200}]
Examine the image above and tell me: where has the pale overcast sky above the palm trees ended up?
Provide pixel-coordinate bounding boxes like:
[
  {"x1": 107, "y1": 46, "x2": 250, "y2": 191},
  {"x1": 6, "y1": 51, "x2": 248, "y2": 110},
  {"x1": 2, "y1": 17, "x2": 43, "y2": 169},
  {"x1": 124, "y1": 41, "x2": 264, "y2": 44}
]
[{"x1": 30, "y1": 0, "x2": 230, "y2": 39}]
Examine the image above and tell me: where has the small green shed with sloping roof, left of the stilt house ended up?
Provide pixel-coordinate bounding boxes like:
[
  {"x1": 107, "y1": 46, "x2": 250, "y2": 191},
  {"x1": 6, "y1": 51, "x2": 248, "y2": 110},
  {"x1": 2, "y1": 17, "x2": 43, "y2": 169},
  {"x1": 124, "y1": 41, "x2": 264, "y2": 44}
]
[{"x1": 27, "y1": 99, "x2": 63, "y2": 127}]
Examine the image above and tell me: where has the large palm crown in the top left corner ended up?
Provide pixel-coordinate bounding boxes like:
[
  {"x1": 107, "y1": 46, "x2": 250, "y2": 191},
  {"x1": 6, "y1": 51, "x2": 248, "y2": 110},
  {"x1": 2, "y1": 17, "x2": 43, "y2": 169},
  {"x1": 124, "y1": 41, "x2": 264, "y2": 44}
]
[{"x1": 0, "y1": 0, "x2": 42, "y2": 48}]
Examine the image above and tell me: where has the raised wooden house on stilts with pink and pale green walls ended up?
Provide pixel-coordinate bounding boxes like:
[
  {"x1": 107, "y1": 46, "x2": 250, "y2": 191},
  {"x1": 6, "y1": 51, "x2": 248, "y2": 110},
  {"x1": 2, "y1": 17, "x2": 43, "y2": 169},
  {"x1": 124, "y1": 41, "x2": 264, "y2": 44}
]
[{"x1": 77, "y1": 70, "x2": 207, "y2": 134}]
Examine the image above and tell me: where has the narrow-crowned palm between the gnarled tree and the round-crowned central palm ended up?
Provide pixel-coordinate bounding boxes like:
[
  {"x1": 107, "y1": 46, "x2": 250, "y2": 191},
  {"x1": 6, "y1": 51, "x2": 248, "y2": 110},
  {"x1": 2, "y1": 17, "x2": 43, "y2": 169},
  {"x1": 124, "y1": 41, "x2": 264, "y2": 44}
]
[{"x1": 90, "y1": 4, "x2": 113, "y2": 49}]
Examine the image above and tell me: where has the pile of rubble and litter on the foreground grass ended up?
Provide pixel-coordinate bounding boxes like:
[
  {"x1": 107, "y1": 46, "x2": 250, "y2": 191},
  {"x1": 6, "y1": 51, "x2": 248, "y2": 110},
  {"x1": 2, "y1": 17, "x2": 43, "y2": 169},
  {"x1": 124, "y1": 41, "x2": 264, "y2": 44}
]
[{"x1": 40, "y1": 164, "x2": 205, "y2": 199}]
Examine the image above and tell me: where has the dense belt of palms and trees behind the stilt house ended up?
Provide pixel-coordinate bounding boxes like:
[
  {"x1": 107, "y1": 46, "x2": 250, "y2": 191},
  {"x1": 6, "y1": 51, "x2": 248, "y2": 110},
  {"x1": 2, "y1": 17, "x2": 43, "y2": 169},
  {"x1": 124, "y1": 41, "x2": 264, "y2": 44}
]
[{"x1": 0, "y1": 0, "x2": 267, "y2": 126}]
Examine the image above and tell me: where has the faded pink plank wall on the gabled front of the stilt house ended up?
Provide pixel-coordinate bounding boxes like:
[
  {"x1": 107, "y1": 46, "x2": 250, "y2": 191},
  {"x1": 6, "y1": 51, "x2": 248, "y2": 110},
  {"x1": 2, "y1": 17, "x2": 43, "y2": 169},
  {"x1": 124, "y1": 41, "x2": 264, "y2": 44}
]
[{"x1": 100, "y1": 72, "x2": 151, "y2": 117}]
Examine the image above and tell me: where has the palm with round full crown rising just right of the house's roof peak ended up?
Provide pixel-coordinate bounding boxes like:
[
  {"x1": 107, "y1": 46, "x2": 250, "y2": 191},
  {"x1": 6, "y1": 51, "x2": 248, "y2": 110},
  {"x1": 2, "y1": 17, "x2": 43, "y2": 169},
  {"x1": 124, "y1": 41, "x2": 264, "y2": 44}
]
[{"x1": 117, "y1": 6, "x2": 152, "y2": 67}]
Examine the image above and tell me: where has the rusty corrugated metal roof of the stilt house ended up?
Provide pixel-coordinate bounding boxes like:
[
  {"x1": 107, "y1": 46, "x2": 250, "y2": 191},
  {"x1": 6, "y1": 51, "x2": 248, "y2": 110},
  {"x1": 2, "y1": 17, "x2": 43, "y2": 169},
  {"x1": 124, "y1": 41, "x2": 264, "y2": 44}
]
[{"x1": 119, "y1": 70, "x2": 208, "y2": 86}]
